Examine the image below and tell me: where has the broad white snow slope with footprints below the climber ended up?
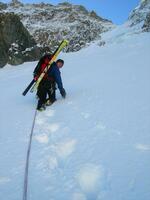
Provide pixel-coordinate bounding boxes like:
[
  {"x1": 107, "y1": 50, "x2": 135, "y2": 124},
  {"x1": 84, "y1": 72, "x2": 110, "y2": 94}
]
[{"x1": 0, "y1": 29, "x2": 150, "y2": 200}]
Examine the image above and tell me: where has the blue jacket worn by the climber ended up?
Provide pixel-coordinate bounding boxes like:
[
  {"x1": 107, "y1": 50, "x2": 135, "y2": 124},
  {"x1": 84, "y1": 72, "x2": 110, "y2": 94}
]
[{"x1": 47, "y1": 62, "x2": 63, "y2": 91}]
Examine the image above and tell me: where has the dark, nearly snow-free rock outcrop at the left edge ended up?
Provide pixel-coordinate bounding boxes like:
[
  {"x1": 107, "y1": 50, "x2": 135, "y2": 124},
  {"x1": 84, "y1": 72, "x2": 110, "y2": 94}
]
[{"x1": 0, "y1": 13, "x2": 50, "y2": 67}]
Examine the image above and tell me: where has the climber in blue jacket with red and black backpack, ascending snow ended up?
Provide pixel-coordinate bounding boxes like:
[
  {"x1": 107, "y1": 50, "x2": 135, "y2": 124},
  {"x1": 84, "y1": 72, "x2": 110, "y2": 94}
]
[{"x1": 34, "y1": 54, "x2": 66, "y2": 111}]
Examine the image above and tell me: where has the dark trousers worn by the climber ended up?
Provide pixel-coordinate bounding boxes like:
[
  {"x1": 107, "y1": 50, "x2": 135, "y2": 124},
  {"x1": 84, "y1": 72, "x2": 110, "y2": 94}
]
[{"x1": 37, "y1": 80, "x2": 56, "y2": 108}]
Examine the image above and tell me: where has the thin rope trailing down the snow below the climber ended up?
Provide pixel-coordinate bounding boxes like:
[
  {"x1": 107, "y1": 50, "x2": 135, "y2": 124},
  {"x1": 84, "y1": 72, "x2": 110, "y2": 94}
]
[{"x1": 23, "y1": 109, "x2": 37, "y2": 200}]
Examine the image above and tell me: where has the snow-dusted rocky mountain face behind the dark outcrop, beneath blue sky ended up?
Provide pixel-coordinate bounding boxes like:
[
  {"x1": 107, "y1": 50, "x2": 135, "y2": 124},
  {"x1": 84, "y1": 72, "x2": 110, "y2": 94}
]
[{"x1": 3, "y1": 0, "x2": 114, "y2": 51}]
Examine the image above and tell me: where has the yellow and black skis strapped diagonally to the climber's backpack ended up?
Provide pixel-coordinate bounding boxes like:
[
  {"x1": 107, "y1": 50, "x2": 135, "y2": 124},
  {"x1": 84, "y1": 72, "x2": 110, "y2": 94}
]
[{"x1": 22, "y1": 40, "x2": 69, "y2": 96}]
